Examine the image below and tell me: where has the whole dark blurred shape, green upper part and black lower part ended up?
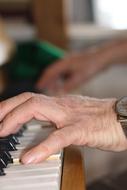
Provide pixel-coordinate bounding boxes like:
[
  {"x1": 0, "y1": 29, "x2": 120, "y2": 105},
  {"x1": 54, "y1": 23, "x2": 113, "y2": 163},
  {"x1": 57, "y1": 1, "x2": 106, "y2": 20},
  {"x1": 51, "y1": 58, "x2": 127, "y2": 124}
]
[{"x1": 0, "y1": 40, "x2": 64, "y2": 101}]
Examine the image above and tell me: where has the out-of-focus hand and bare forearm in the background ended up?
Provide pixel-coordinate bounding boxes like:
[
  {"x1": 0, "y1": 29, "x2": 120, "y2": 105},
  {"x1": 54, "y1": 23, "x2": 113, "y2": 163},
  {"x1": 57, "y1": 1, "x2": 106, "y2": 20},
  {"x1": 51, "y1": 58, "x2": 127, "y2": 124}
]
[{"x1": 36, "y1": 39, "x2": 127, "y2": 95}]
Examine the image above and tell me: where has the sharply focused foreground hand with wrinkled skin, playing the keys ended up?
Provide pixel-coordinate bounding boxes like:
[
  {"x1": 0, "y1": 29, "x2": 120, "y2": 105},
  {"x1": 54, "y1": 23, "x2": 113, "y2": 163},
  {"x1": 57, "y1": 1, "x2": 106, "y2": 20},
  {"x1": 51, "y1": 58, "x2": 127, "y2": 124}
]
[{"x1": 0, "y1": 93, "x2": 127, "y2": 163}]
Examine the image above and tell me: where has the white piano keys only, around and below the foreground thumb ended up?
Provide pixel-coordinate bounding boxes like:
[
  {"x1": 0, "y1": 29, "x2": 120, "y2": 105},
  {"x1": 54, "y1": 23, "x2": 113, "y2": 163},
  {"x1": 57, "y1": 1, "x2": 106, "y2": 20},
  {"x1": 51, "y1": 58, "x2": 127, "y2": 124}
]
[{"x1": 0, "y1": 121, "x2": 62, "y2": 190}]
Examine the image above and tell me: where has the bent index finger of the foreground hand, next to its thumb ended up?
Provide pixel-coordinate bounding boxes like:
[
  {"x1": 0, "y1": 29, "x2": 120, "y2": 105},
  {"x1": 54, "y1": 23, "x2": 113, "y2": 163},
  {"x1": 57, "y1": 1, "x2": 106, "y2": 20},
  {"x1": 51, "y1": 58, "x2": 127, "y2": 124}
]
[{"x1": 0, "y1": 99, "x2": 47, "y2": 137}]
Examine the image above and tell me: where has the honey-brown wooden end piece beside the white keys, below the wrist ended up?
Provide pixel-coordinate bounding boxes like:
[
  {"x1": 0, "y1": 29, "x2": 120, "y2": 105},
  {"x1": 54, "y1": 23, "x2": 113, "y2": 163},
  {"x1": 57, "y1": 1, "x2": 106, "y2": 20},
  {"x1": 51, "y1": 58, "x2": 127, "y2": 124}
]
[{"x1": 61, "y1": 147, "x2": 85, "y2": 190}]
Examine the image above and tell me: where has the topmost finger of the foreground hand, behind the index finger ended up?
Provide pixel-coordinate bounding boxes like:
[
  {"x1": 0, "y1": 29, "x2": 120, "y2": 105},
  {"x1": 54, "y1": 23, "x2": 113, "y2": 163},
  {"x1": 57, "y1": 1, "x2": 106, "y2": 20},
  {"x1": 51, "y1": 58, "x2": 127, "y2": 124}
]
[{"x1": 0, "y1": 92, "x2": 34, "y2": 121}]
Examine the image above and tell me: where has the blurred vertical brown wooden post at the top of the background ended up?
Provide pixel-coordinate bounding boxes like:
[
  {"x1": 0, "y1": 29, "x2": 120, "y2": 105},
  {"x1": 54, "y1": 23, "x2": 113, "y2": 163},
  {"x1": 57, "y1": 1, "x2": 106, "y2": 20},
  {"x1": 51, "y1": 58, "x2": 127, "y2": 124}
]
[{"x1": 33, "y1": 0, "x2": 67, "y2": 49}]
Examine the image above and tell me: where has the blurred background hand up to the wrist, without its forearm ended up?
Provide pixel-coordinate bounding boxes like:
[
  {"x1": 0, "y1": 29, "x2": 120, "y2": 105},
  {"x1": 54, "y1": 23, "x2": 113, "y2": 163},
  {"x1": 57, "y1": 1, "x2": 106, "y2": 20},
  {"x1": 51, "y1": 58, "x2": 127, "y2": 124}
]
[{"x1": 36, "y1": 49, "x2": 107, "y2": 94}]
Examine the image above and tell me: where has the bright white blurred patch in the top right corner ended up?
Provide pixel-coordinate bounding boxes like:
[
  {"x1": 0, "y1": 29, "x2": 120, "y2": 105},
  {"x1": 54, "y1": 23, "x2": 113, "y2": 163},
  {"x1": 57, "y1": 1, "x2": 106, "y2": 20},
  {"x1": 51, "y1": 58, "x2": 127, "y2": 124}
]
[{"x1": 93, "y1": 0, "x2": 127, "y2": 29}]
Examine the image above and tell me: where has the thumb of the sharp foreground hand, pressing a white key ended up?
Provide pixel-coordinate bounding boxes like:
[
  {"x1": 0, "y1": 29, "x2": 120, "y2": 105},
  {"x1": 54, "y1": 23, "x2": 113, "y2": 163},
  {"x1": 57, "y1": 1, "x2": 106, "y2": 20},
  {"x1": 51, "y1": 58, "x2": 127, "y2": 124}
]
[{"x1": 21, "y1": 126, "x2": 77, "y2": 164}]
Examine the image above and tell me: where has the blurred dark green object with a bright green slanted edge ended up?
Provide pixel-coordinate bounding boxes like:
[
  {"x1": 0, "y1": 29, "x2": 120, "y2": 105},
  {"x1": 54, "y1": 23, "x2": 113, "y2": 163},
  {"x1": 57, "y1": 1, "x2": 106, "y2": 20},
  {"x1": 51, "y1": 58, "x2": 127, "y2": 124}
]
[{"x1": 8, "y1": 40, "x2": 65, "y2": 81}]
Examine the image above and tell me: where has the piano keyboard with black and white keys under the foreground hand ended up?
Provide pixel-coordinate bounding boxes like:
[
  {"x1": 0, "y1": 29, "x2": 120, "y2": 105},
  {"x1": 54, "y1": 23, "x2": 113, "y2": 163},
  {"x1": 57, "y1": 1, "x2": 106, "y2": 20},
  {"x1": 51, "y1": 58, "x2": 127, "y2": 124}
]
[{"x1": 0, "y1": 122, "x2": 62, "y2": 190}]
